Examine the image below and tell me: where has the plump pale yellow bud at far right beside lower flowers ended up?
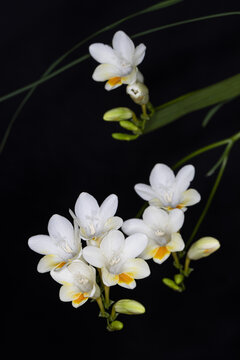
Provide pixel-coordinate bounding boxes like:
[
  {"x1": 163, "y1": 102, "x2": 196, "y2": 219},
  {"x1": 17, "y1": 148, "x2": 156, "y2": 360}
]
[{"x1": 187, "y1": 236, "x2": 220, "y2": 260}]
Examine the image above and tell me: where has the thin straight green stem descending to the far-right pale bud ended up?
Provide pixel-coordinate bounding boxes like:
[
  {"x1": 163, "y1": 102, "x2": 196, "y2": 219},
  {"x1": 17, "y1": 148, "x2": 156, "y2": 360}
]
[{"x1": 186, "y1": 153, "x2": 229, "y2": 249}]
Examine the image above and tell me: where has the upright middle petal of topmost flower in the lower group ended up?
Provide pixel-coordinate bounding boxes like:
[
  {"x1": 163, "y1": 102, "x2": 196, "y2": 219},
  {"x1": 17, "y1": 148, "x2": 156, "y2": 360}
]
[{"x1": 149, "y1": 164, "x2": 175, "y2": 189}]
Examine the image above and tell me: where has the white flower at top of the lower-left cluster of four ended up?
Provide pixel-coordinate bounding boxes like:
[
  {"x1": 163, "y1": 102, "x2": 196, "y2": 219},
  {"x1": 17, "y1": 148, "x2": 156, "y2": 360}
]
[{"x1": 72, "y1": 192, "x2": 123, "y2": 245}]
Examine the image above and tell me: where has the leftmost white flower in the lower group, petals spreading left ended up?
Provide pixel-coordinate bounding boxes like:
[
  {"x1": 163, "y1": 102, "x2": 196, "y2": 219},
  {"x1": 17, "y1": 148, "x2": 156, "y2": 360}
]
[{"x1": 28, "y1": 214, "x2": 82, "y2": 273}]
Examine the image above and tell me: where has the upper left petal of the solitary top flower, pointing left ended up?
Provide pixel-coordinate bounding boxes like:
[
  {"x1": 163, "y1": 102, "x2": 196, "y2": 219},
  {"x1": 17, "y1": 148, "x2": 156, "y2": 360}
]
[{"x1": 89, "y1": 43, "x2": 119, "y2": 66}]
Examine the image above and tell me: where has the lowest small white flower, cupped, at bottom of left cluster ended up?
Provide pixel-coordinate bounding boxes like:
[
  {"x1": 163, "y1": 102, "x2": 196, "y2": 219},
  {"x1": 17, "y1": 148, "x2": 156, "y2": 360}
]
[{"x1": 50, "y1": 260, "x2": 100, "y2": 308}]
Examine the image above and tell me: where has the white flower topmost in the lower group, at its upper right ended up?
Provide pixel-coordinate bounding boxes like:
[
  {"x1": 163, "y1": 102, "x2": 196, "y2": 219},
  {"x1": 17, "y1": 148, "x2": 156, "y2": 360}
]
[{"x1": 134, "y1": 164, "x2": 201, "y2": 211}]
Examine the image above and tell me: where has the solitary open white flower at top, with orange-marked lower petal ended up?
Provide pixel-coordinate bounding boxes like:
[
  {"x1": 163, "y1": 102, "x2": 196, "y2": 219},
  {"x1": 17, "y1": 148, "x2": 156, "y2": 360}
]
[{"x1": 89, "y1": 31, "x2": 146, "y2": 90}]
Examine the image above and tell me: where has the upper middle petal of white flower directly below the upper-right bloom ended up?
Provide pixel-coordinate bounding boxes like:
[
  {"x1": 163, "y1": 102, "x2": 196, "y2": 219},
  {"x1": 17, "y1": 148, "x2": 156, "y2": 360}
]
[{"x1": 143, "y1": 206, "x2": 168, "y2": 231}]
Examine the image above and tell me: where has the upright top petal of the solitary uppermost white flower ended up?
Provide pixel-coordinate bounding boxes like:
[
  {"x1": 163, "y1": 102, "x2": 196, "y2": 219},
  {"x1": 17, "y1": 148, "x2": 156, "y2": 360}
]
[{"x1": 112, "y1": 31, "x2": 135, "y2": 64}]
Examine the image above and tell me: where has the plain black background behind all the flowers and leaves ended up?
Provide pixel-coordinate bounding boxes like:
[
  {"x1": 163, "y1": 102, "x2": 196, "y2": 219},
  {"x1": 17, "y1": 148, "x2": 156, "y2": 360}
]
[{"x1": 0, "y1": 0, "x2": 240, "y2": 359}]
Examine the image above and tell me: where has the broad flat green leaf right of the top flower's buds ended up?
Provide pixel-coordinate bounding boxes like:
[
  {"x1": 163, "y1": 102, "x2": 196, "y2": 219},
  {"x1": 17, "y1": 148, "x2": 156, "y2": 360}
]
[{"x1": 144, "y1": 74, "x2": 240, "y2": 133}]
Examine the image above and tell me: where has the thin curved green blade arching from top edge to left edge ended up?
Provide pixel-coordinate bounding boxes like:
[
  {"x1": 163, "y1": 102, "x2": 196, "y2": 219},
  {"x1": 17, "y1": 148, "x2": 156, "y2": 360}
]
[{"x1": 0, "y1": 0, "x2": 183, "y2": 154}]
